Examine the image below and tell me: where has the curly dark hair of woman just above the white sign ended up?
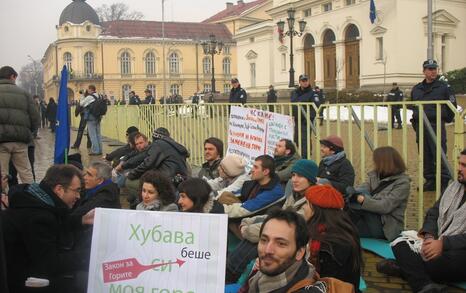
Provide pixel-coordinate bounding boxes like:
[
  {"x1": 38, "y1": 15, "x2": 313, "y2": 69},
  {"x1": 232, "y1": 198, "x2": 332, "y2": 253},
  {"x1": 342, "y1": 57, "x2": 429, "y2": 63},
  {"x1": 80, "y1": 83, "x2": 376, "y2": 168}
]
[{"x1": 139, "y1": 170, "x2": 176, "y2": 206}]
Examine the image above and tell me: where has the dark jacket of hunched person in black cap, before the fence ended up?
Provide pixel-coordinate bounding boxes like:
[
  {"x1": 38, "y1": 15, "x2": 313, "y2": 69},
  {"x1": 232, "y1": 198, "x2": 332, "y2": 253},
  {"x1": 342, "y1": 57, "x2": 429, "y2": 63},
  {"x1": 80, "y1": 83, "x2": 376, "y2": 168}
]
[{"x1": 128, "y1": 137, "x2": 189, "y2": 180}]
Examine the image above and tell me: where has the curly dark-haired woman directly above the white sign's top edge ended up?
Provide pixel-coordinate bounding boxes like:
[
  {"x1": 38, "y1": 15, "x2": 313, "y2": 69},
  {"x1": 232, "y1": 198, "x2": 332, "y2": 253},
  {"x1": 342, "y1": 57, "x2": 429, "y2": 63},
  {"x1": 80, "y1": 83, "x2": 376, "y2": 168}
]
[{"x1": 136, "y1": 171, "x2": 178, "y2": 212}]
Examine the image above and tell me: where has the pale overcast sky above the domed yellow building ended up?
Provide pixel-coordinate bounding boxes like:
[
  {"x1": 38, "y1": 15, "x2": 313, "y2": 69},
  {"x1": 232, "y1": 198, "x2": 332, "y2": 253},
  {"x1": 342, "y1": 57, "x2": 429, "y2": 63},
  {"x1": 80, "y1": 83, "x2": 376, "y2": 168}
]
[{"x1": 0, "y1": 0, "x2": 228, "y2": 71}]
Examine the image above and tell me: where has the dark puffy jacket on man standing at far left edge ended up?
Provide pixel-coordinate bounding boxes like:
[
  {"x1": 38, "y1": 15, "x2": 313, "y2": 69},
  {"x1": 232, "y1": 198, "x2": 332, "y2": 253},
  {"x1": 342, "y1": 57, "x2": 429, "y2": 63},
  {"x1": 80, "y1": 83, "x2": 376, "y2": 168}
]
[{"x1": 0, "y1": 79, "x2": 40, "y2": 143}]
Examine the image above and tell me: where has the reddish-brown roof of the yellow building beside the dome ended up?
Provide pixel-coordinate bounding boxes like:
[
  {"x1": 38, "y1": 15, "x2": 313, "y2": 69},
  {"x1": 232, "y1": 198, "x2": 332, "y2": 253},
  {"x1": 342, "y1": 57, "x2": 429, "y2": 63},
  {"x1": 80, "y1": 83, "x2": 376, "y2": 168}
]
[{"x1": 102, "y1": 20, "x2": 233, "y2": 42}]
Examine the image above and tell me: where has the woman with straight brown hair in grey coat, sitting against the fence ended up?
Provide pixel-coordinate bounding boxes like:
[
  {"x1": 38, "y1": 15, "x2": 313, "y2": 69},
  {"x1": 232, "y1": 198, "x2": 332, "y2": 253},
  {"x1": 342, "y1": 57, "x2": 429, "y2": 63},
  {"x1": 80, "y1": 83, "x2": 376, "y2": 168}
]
[{"x1": 348, "y1": 146, "x2": 410, "y2": 241}]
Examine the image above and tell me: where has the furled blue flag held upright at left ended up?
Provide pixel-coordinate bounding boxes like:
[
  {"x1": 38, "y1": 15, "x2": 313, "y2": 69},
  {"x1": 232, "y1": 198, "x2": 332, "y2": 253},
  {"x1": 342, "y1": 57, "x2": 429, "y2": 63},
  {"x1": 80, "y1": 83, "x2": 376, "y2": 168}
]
[{"x1": 54, "y1": 66, "x2": 70, "y2": 164}]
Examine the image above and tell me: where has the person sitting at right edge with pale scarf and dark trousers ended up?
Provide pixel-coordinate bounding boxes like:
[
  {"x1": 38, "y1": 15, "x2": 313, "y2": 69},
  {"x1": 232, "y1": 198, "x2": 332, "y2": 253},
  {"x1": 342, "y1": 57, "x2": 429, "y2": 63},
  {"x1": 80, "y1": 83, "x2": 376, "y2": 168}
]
[{"x1": 377, "y1": 149, "x2": 466, "y2": 293}]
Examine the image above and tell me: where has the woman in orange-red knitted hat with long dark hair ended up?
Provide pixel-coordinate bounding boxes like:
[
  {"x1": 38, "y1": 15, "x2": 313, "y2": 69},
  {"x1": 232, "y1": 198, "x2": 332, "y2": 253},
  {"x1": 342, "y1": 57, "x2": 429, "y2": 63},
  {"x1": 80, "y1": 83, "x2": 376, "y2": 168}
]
[{"x1": 304, "y1": 185, "x2": 362, "y2": 292}]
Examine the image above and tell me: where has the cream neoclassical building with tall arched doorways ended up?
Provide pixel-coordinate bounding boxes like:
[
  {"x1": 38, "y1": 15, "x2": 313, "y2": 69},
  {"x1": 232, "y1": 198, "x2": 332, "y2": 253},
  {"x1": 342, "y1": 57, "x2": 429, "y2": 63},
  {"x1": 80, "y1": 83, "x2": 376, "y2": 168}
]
[{"x1": 234, "y1": 0, "x2": 466, "y2": 95}]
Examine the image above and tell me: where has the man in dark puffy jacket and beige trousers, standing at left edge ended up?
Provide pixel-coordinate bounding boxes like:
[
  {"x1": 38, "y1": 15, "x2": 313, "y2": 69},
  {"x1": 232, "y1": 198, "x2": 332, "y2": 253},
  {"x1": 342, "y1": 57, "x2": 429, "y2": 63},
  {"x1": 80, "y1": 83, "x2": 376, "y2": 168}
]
[{"x1": 0, "y1": 66, "x2": 40, "y2": 183}]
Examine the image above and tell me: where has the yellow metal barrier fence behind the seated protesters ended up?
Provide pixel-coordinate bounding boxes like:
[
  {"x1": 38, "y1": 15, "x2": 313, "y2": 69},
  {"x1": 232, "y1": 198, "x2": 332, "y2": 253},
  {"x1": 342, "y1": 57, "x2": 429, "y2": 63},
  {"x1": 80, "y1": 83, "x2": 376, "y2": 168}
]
[{"x1": 72, "y1": 101, "x2": 466, "y2": 225}]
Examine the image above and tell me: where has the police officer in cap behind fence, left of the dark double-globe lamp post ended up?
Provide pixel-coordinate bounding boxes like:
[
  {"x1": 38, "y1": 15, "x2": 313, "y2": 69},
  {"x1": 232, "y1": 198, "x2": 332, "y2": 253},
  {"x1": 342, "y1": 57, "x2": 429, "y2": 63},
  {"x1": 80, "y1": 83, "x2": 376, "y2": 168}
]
[{"x1": 291, "y1": 74, "x2": 316, "y2": 159}]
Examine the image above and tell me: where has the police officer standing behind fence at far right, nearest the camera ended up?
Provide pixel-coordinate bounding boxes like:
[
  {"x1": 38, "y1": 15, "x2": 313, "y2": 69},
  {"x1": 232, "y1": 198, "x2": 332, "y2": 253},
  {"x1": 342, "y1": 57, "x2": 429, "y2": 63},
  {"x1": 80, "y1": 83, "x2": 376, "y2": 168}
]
[{"x1": 411, "y1": 59, "x2": 456, "y2": 191}]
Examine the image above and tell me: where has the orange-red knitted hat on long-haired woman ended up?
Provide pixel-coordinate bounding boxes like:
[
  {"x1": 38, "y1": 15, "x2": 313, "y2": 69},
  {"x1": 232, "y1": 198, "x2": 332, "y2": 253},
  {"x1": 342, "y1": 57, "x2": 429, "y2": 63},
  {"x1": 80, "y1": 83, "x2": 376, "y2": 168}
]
[{"x1": 305, "y1": 185, "x2": 345, "y2": 209}]
